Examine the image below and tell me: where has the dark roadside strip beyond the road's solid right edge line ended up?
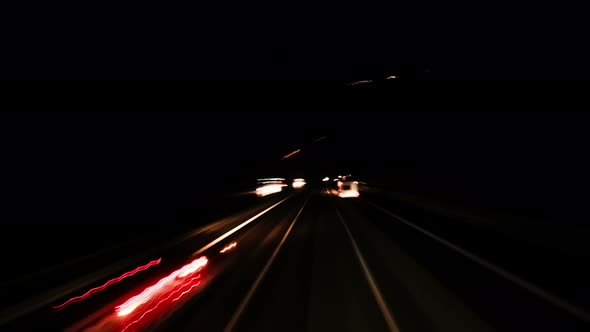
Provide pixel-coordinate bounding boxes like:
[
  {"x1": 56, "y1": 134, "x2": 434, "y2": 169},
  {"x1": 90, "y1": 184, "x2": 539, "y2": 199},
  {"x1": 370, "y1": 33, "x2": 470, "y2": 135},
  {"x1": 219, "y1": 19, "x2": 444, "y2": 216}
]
[{"x1": 363, "y1": 185, "x2": 590, "y2": 320}]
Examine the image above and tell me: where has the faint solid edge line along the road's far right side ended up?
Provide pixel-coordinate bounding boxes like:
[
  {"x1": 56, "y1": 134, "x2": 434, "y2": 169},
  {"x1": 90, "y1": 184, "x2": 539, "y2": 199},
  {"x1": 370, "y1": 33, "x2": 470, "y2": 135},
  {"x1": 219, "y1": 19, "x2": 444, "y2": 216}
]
[{"x1": 365, "y1": 200, "x2": 590, "y2": 322}]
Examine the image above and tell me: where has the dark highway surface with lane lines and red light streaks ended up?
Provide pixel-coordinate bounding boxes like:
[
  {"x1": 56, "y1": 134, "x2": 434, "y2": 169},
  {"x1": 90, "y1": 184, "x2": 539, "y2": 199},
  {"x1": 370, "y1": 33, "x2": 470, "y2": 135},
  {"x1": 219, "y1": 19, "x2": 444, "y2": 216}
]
[{"x1": 0, "y1": 188, "x2": 590, "y2": 332}]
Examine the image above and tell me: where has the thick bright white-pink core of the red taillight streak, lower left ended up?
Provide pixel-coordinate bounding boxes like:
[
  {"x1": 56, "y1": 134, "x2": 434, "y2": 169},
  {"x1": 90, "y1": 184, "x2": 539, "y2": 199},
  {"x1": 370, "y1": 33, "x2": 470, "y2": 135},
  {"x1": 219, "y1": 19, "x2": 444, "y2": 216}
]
[{"x1": 116, "y1": 257, "x2": 208, "y2": 316}]
